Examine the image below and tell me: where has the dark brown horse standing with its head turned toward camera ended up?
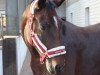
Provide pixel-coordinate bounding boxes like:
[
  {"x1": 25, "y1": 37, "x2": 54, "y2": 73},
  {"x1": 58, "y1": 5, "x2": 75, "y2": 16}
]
[{"x1": 21, "y1": 0, "x2": 100, "y2": 75}]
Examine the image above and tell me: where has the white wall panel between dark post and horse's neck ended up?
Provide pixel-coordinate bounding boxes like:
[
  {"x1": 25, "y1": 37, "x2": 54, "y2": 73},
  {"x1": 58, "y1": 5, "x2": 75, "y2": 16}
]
[{"x1": 16, "y1": 36, "x2": 27, "y2": 75}]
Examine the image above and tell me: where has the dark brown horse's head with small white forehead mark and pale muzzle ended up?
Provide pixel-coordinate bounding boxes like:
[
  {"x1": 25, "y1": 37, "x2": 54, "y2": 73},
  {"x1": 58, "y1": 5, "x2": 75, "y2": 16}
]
[{"x1": 21, "y1": 0, "x2": 66, "y2": 74}]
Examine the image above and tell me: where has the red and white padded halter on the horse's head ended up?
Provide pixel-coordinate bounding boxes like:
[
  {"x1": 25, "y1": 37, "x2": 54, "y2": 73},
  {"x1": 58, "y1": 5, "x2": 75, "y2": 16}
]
[{"x1": 29, "y1": 0, "x2": 66, "y2": 63}]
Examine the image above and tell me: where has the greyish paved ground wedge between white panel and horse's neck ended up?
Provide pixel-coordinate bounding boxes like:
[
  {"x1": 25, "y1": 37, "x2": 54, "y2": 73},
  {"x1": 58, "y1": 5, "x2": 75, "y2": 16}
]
[{"x1": 20, "y1": 51, "x2": 33, "y2": 75}]
